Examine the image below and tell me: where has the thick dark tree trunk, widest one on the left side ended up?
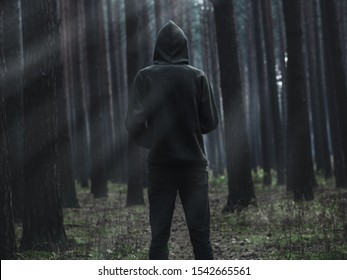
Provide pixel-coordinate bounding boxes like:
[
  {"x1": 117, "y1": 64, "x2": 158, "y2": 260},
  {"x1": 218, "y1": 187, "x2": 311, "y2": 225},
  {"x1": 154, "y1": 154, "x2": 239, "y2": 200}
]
[{"x1": 21, "y1": 0, "x2": 66, "y2": 250}]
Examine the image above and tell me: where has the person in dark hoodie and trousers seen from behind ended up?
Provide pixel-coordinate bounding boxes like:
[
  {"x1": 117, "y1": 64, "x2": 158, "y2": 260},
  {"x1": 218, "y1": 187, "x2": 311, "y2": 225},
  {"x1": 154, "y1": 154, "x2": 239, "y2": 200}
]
[{"x1": 126, "y1": 21, "x2": 218, "y2": 259}]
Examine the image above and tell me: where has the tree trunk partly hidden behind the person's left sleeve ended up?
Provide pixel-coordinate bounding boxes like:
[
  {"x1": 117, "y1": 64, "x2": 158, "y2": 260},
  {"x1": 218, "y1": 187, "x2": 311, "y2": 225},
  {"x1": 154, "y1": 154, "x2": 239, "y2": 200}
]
[{"x1": 125, "y1": 0, "x2": 146, "y2": 206}]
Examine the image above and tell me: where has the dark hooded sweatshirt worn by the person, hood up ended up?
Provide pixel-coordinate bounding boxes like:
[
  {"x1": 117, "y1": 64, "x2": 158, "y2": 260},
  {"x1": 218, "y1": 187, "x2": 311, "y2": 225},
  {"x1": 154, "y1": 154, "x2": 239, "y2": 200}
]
[{"x1": 126, "y1": 21, "x2": 218, "y2": 171}]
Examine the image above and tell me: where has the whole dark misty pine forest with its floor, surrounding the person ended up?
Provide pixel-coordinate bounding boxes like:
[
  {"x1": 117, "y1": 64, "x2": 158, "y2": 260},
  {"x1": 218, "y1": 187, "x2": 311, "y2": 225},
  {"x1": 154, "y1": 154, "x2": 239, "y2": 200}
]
[{"x1": 0, "y1": 0, "x2": 347, "y2": 260}]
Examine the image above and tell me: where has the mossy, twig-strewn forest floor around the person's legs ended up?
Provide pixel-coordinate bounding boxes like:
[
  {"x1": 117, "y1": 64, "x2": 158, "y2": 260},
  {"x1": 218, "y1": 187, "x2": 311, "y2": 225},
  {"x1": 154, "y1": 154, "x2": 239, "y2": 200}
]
[{"x1": 17, "y1": 174, "x2": 347, "y2": 260}]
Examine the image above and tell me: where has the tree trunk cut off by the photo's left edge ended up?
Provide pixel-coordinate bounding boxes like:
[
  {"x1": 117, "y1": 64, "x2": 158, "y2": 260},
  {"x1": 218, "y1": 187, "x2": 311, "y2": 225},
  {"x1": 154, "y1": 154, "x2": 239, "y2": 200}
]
[{"x1": 0, "y1": 1, "x2": 18, "y2": 260}]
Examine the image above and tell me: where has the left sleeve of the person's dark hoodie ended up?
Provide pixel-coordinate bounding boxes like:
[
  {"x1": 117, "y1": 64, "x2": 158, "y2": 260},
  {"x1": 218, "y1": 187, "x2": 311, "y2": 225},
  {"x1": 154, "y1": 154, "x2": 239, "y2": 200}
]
[{"x1": 125, "y1": 73, "x2": 151, "y2": 149}]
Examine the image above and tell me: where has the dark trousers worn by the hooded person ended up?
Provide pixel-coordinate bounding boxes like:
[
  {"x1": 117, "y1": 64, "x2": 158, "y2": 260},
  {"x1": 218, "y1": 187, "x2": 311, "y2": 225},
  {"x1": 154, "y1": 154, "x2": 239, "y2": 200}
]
[{"x1": 148, "y1": 178, "x2": 213, "y2": 260}]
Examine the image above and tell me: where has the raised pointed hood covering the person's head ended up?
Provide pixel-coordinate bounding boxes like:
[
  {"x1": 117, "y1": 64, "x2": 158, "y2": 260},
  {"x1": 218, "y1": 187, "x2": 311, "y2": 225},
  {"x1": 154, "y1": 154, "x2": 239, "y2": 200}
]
[{"x1": 153, "y1": 20, "x2": 189, "y2": 64}]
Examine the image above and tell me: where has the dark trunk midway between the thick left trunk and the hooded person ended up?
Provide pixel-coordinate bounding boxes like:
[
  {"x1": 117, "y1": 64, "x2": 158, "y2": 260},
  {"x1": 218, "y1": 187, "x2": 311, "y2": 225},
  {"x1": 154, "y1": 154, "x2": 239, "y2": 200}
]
[{"x1": 84, "y1": 0, "x2": 110, "y2": 198}]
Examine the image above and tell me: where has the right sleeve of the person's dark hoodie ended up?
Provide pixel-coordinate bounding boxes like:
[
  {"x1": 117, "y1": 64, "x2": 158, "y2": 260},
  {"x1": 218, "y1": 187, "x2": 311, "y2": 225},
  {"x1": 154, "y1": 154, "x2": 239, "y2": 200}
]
[{"x1": 199, "y1": 72, "x2": 219, "y2": 134}]
